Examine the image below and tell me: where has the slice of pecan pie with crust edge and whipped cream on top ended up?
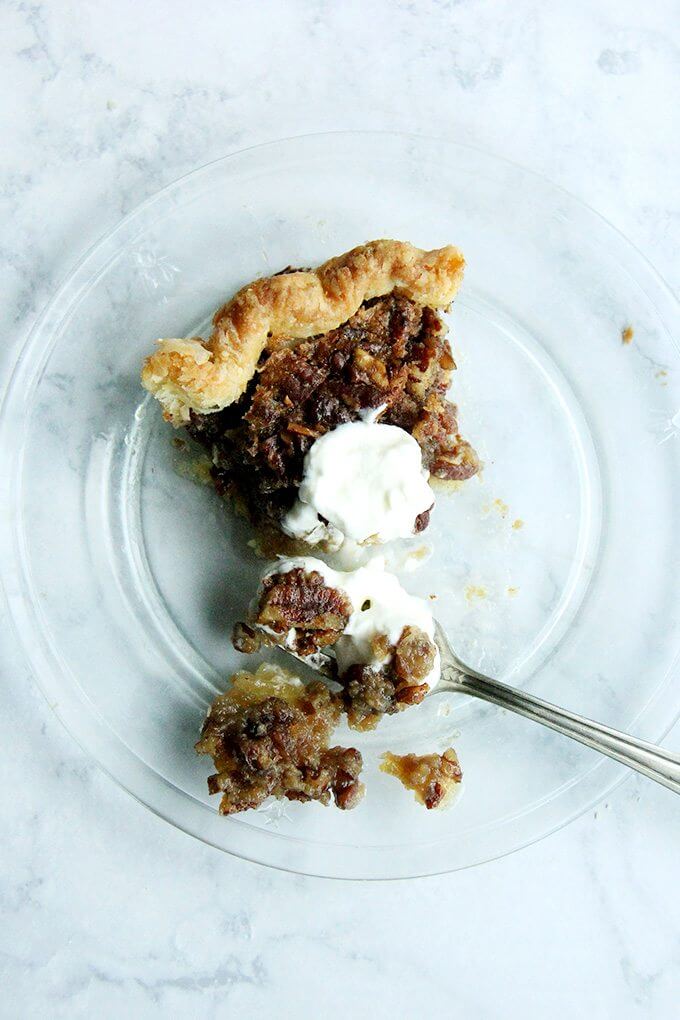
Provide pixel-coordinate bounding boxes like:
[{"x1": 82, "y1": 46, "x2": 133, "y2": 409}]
[{"x1": 142, "y1": 241, "x2": 479, "y2": 546}]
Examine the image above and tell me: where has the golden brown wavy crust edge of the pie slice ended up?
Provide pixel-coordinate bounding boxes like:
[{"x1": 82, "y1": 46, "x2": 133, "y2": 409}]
[{"x1": 142, "y1": 241, "x2": 465, "y2": 425}]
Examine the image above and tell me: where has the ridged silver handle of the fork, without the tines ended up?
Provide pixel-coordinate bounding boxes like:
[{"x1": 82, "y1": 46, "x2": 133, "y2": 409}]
[{"x1": 452, "y1": 669, "x2": 680, "y2": 794}]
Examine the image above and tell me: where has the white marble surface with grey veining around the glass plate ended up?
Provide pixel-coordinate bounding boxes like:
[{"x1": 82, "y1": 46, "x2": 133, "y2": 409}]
[{"x1": 0, "y1": 0, "x2": 680, "y2": 1020}]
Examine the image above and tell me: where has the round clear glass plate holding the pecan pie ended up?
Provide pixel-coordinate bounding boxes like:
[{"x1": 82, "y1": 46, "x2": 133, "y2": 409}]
[{"x1": 1, "y1": 134, "x2": 680, "y2": 878}]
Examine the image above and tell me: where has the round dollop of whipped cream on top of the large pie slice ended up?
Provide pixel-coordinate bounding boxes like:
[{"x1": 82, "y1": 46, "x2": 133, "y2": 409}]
[{"x1": 281, "y1": 408, "x2": 434, "y2": 549}]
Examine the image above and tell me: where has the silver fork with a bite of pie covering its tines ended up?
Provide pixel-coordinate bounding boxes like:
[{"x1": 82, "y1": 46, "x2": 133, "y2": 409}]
[{"x1": 283, "y1": 622, "x2": 680, "y2": 794}]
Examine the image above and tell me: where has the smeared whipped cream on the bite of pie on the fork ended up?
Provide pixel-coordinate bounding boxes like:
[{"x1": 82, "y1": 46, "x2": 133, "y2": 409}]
[{"x1": 268, "y1": 556, "x2": 440, "y2": 690}]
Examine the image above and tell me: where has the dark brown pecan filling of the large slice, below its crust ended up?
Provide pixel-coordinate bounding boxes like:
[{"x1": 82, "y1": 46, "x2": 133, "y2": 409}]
[{"x1": 187, "y1": 293, "x2": 479, "y2": 531}]
